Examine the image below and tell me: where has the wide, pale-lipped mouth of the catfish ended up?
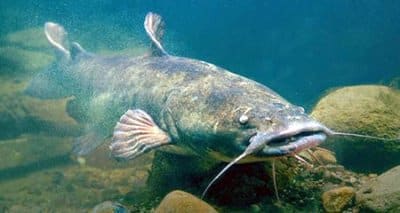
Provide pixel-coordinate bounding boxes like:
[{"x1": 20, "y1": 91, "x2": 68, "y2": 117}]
[{"x1": 250, "y1": 122, "x2": 329, "y2": 157}]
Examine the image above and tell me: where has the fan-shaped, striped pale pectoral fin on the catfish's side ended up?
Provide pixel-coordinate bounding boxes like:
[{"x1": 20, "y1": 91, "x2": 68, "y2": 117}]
[{"x1": 110, "y1": 109, "x2": 171, "y2": 160}]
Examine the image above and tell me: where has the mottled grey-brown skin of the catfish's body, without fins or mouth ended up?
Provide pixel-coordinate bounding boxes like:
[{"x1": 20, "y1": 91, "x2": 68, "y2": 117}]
[{"x1": 28, "y1": 52, "x2": 309, "y2": 161}]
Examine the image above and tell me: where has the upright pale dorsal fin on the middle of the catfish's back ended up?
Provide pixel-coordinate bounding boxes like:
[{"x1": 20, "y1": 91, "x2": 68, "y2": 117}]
[{"x1": 144, "y1": 12, "x2": 168, "y2": 56}]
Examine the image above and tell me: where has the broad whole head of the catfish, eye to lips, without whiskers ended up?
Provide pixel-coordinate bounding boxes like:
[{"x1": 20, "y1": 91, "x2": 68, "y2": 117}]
[{"x1": 200, "y1": 85, "x2": 329, "y2": 161}]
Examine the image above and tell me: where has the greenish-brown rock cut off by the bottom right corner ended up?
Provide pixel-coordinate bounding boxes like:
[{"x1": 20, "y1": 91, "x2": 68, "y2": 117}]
[{"x1": 356, "y1": 165, "x2": 400, "y2": 212}]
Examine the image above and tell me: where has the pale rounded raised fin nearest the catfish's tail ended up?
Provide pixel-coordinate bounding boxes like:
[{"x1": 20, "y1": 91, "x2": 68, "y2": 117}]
[{"x1": 44, "y1": 22, "x2": 71, "y2": 58}]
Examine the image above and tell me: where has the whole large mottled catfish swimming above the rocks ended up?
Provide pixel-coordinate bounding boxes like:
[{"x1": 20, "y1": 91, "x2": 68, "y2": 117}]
[{"x1": 26, "y1": 13, "x2": 388, "y2": 199}]
